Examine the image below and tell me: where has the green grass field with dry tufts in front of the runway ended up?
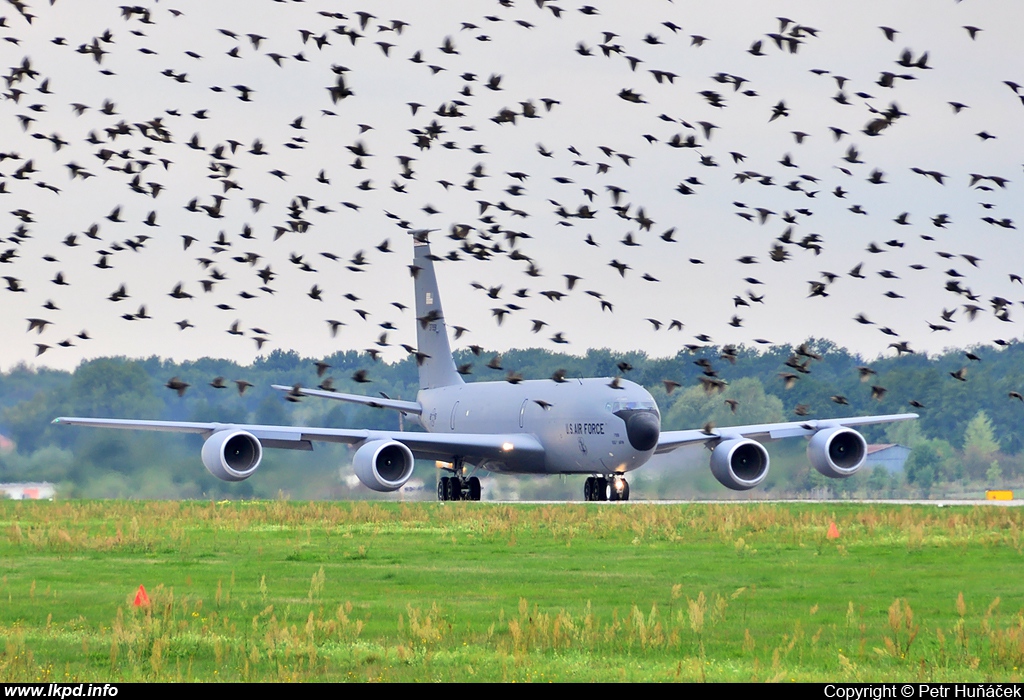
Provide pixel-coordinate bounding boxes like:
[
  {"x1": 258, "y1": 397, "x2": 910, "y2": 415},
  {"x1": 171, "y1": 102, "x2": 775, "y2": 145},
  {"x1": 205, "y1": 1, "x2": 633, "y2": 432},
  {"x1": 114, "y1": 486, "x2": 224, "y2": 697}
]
[{"x1": 0, "y1": 501, "x2": 1024, "y2": 682}]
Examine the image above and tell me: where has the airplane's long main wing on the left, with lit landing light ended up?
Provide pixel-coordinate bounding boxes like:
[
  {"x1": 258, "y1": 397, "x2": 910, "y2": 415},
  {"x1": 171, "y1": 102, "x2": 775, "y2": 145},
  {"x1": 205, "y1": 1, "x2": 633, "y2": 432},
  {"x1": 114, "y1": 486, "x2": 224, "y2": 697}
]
[{"x1": 53, "y1": 415, "x2": 544, "y2": 464}]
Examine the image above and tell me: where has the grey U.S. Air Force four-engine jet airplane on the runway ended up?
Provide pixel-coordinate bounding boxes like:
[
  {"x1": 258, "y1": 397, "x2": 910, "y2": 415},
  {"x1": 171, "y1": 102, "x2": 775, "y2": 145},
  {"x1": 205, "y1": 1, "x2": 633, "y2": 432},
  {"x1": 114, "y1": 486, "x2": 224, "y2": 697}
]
[{"x1": 53, "y1": 239, "x2": 918, "y2": 500}]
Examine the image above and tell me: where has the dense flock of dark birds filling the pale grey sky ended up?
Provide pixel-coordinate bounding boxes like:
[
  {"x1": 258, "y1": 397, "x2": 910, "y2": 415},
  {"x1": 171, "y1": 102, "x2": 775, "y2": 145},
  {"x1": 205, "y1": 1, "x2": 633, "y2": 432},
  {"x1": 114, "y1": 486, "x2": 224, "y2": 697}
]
[{"x1": 0, "y1": 0, "x2": 1024, "y2": 413}]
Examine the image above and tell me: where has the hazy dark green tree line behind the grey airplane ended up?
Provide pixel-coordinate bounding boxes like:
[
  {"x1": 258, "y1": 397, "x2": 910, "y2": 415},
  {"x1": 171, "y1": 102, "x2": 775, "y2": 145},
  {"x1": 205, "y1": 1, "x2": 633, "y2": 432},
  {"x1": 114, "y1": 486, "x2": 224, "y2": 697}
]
[{"x1": 0, "y1": 339, "x2": 1024, "y2": 498}]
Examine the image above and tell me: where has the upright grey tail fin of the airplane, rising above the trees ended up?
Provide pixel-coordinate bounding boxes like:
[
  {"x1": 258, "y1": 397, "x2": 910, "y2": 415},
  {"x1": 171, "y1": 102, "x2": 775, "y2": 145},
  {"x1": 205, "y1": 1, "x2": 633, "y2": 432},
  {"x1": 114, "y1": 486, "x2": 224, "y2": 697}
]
[{"x1": 413, "y1": 244, "x2": 463, "y2": 389}]
